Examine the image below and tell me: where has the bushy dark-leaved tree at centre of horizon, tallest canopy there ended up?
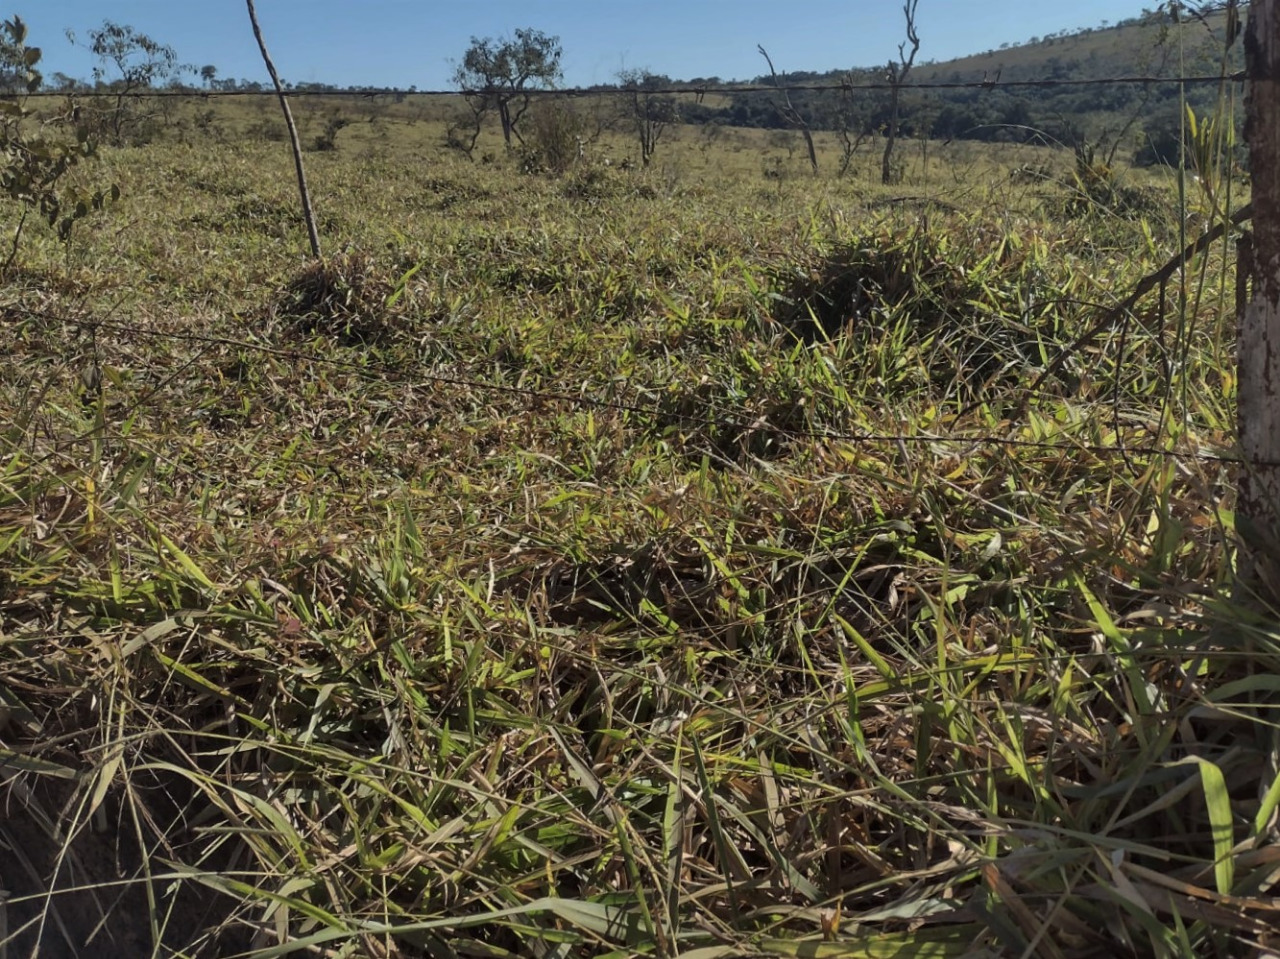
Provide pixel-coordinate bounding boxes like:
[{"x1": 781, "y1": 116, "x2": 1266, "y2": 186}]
[{"x1": 453, "y1": 28, "x2": 563, "y2": 149}]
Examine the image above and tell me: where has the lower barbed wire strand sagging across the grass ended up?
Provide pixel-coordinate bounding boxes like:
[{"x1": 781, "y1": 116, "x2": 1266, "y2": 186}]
[{"x1": 4, "y1": 306, "x2": 1249, "y2": 469}]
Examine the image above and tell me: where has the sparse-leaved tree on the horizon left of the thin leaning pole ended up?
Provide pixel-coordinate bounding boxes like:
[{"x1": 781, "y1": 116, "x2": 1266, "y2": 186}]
[{"x1": 67, "y1": 20, "x2": 189, "y2": 146}]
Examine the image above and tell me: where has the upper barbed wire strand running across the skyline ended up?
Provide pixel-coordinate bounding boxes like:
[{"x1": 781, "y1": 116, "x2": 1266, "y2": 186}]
[{"x1": 27, "y1": 70, "x2": 1248, "y2": 100}]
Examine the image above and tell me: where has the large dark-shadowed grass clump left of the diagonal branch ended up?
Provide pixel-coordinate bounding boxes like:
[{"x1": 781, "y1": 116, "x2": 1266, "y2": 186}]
[{"x1": 778, "y1": 214, "x2": 1079, "y2": 401}]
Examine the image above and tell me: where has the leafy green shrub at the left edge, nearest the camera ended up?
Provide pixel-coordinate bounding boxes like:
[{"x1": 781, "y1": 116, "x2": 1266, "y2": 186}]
[{"x1": 0, "y1": 17, "x2": 120, "y2": 270}]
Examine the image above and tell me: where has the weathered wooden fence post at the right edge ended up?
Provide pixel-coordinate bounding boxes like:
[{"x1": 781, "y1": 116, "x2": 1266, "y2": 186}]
[{"x1": 1236, "y1": 0, "x2": 1280, "y2": 598}]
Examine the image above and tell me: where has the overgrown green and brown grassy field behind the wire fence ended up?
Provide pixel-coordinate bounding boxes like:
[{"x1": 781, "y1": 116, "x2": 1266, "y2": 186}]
[{"x1": 0, "y1": 102, "x2": 1280, "y2": 959}]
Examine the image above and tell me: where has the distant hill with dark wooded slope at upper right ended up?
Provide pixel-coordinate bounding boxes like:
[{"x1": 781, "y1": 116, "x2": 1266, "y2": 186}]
[{"x1": 684, "y1": 5, "x2": 1247, "y2": 163}]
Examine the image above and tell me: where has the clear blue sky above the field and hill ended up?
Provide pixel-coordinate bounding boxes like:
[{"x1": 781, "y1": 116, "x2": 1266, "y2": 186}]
[{"x1": 22, "y1": 0, "x2": 1156, "y2": 90}]
